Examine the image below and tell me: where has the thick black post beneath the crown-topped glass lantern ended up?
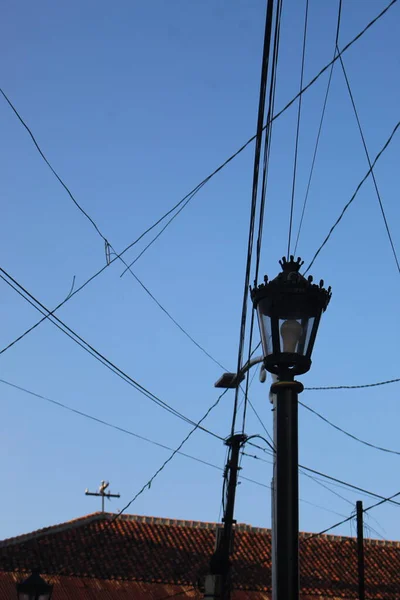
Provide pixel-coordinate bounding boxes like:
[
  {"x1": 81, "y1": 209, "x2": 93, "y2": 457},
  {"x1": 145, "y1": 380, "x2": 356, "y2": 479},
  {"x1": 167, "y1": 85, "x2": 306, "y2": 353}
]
[{"x1": 271, "y1": 377, "x2": 303, "y2": 600}]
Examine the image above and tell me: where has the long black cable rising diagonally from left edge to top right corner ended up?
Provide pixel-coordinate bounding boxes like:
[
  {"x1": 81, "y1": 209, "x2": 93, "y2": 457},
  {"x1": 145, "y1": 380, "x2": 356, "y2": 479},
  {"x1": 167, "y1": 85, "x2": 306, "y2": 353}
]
[{"x1": 0, "y1": 0, "x2": 398, "y2": 354}]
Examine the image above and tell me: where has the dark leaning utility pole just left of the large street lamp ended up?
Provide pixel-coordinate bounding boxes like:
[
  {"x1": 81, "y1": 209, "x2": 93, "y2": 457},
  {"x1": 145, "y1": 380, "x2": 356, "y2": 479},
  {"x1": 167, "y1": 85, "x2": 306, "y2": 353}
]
[{"x1": 205, "y1": 434, "x2": 247, "y2": 600}]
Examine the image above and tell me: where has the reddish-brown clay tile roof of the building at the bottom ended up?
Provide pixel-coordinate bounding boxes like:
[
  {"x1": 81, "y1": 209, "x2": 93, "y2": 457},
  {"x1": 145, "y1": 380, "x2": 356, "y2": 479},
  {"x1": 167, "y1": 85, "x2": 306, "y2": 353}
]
[{"x1": 0, "y1": 513, "x2": 400, "y2": 600}]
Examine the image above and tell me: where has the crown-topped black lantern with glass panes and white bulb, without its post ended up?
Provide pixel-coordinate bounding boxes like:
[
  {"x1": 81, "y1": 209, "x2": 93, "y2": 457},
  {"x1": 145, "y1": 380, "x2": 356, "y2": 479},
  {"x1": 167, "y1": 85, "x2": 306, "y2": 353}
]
[{"x1": 251, "y1": 256, "x2": 331, "y2": 377}]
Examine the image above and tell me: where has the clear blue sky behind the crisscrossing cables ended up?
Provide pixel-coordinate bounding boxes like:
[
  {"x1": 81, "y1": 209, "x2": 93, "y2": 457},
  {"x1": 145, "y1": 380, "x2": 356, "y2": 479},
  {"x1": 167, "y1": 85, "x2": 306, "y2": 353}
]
[{"x1": 0, "y1": 0, "x2": 400, "y2": 539}]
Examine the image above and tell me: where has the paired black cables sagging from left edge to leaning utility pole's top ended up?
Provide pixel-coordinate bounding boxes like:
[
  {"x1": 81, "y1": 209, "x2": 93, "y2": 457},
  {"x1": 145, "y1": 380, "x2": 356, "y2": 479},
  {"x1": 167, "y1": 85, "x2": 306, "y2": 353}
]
[{"x1": 0, "y1": 267, "x2": 222, "y2": 439}]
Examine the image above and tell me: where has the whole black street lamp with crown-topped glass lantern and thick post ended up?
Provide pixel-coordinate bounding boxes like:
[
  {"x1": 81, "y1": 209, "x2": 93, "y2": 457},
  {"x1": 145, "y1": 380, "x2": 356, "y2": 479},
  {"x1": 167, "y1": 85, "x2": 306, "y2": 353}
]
[{"x1": 251, "y1": 256, "x2": 331, "y2": 600}]
